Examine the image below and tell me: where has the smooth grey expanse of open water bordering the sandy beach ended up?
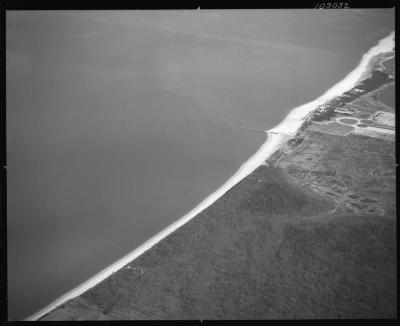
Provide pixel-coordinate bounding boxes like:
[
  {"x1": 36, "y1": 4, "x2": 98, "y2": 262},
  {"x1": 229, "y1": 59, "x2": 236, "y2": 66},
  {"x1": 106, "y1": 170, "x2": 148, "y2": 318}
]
[{"x1": 6, "y1": 10, "x2": 394, "y2": 319}]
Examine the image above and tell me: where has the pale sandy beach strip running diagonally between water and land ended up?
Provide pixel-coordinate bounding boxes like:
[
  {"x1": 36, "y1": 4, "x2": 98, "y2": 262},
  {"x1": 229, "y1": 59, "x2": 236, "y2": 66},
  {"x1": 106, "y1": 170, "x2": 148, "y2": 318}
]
[{"x1": 25, "y1": 32, "x2": 395, "y2": 320}]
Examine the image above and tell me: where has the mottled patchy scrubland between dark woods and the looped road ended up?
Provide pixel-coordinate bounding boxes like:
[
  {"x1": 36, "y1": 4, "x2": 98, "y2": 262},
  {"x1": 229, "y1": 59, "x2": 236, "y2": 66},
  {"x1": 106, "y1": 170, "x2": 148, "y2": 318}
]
[{"x1": 280, "y1": 131, "x2": 395, "y2": 214}]
